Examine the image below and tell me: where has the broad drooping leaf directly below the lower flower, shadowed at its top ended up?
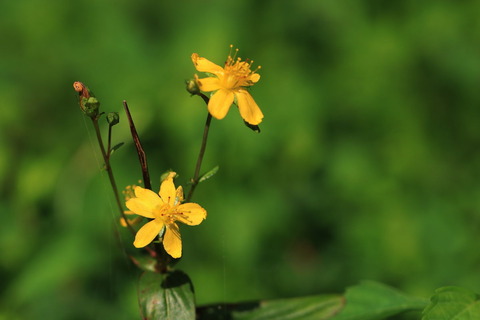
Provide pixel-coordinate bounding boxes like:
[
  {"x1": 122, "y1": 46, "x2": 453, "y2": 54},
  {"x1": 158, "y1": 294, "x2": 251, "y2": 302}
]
[{"x1": 138, "y1": 270, "x2": 195, "y2": 320}]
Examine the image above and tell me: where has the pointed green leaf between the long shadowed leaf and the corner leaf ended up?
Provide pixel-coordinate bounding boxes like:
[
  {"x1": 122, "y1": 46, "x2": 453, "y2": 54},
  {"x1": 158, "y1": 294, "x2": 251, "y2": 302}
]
[{"x1": 333, "y1": 281, "x2": 427, "y2": 320}]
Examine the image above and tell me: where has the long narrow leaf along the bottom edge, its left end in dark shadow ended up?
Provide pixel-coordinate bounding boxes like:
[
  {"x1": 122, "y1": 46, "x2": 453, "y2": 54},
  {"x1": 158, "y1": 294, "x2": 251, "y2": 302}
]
[{"x1": 197, "y1": 295, "x2": 344, "y2": 320}]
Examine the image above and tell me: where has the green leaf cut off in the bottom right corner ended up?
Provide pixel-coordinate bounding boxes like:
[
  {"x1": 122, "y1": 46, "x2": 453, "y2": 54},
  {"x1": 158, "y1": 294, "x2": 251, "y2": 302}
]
[{"x1": 422, "y1": 287, "x2": 480, "y2": 320}]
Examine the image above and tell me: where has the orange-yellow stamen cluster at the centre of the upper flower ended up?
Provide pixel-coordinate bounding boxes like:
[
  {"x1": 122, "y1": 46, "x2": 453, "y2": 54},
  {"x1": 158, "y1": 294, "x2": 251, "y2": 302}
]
[{"x1": 218, "y1": 45, "x2": 261, "y2": 89}]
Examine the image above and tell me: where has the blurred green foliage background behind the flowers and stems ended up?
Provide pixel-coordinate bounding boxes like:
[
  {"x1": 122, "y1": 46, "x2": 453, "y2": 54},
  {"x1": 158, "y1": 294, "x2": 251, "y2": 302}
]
[{"x1": 0, "y1": 0, "x2": 480, "y2": 320}]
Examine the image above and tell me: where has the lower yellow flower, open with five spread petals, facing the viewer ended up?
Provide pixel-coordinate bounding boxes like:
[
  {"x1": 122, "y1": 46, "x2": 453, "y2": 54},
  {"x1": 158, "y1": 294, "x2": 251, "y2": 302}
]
[{"x1": 126, "y1": 172, "x2": 207, "y2": 258}]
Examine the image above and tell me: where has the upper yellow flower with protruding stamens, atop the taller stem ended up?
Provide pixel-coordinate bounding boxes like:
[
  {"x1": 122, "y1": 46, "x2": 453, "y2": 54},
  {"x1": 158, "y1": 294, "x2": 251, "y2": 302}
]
[{"x1": 192, "y1": 46, "x2": 263, "y2": 125}]
